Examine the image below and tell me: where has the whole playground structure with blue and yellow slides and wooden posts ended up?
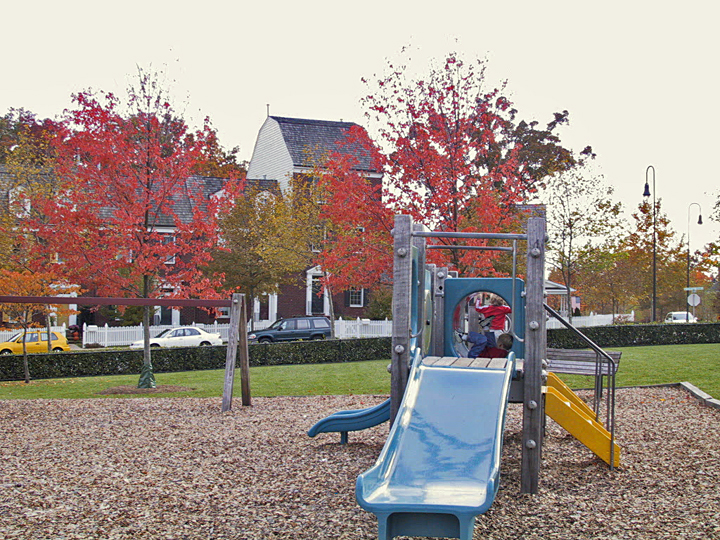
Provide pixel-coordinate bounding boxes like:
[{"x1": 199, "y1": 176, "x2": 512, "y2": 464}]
[{"x1": 308, "y1": 215, "x2": 620, "y2": 540}]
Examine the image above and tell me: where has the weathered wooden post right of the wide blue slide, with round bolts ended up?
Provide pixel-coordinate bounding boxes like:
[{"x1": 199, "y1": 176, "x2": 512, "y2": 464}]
[{"x1": 520, "y1": 218, "x2": 547, "y2": 493}]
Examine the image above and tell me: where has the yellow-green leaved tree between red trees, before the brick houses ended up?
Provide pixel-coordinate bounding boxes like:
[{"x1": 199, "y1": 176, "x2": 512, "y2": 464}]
[{"x1": 205, "y1": 178, "x2": 322, "y2": 325}]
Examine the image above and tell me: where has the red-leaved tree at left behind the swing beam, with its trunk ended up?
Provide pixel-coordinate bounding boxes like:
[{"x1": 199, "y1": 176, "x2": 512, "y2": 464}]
[{"x1": 27, "y1": 70, "x2": 239, "y2": 387}]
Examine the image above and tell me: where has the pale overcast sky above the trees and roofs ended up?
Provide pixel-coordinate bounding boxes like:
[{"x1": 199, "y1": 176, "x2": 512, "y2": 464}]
[{"x1": 5, "y1": 0, "x2": 720, "y2": 253}]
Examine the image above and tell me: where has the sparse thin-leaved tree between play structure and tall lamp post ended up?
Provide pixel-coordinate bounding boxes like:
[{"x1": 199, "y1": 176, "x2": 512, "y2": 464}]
[{"x1": 540, "y1": 169, "x2": 622, "y2": 318}]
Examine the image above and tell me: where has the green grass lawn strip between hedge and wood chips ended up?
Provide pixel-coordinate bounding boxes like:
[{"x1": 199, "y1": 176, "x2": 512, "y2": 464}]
[{"x1": 0, "y1": 343, "x2": 720, "y2": 399}]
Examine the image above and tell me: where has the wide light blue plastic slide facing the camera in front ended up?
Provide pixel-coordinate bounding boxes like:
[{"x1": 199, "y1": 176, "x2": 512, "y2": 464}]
[{"x1": 355, "y1": 354, "x2": 515, "y2": 540}]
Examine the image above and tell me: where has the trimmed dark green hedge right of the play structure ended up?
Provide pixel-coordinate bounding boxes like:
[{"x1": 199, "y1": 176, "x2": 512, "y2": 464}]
[{"x1": 547, "y1": 323, "x2": 720, "y2": 349}]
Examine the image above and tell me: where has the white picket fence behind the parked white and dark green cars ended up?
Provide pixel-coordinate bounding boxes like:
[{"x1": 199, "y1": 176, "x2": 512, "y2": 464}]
[{"x1": 82, "y1": 319, "x2": 392, "y2": 347}]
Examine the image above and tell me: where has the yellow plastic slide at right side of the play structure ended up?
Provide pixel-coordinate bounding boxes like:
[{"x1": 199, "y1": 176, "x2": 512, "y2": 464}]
[{"x1": 545, "y1": 373, "x2": 620, "y2": 467}]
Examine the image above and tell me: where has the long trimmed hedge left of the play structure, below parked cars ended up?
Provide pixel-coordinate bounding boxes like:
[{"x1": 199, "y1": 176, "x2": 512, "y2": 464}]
[{"x1": 0, "y1": 337, "x2": 391, "y2": 381}]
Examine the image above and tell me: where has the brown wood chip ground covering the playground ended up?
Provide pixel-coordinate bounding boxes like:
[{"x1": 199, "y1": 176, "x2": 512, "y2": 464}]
[{"x1": 0, "y1": 388, "x2": 720, "y2": 540}]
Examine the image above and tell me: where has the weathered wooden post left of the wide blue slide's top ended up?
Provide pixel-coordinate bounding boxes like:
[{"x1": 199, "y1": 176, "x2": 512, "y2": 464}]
[{"x1": 390, "y1": 215, "x2": 412, "y2": 424}]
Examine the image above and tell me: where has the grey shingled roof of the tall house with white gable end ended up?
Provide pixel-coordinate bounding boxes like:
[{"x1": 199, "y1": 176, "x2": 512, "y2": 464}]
[{"x1": 270, "y1": 116, "x2": 376, "y2": 172}]
